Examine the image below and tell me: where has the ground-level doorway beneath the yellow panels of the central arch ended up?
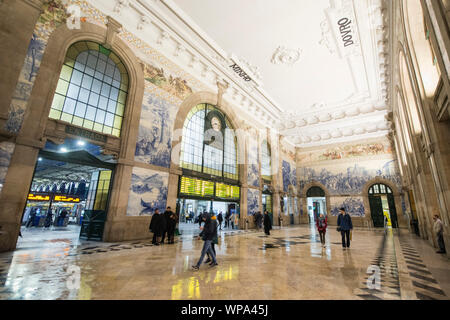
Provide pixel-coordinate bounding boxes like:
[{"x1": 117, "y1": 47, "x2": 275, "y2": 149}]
[{"x1": 177, "y1": 198, "x2": 240, "y2": 236}]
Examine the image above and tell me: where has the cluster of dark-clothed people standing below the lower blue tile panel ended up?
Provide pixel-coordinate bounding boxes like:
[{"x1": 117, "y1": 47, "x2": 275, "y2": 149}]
[{"x1": 149, "y1": 207, "x2": 178, "y2": 246}]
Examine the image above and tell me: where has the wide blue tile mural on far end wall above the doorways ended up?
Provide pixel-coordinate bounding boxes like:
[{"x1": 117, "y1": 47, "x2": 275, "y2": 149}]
[{"x1": 298, "y1": 160, "x2": 401, "y2": 195}]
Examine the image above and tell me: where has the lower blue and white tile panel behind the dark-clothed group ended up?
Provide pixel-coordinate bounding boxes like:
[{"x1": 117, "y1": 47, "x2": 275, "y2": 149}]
[{"x1": 127, "y1": 167, "x2": 169, "y2": 216}]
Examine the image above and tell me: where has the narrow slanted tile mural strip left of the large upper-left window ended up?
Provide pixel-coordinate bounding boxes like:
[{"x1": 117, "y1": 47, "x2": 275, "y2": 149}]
[{"x1": 5, "y1": 34, "x2": 46, "y2": 133}]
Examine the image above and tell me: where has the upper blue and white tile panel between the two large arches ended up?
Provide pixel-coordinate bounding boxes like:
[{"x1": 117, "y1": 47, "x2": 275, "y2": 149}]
[{"x1": 135, "y1": 93, "x2": 178, "y2": 168}]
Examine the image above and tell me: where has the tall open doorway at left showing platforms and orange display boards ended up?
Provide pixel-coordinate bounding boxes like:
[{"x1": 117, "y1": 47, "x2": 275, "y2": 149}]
[{"x1": 17, "y1": 139, "x2": 115, "y2": 248}]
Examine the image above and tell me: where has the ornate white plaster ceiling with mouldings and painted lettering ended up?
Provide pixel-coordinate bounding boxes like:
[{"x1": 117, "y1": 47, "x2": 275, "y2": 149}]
[{"x1": 91, "y1": 0, "x2": 392, "y2": 147}]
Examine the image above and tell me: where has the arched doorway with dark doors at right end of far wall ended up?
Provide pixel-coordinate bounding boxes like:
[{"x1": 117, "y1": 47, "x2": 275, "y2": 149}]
[{"x1": 369, "y1": 183, "x2": 398, "y2": 228}]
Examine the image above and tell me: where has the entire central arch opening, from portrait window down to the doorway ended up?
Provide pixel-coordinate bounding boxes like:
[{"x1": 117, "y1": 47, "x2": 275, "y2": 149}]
[{"x1": 177, "y1": 103, "x2": 240, "y2": 238}]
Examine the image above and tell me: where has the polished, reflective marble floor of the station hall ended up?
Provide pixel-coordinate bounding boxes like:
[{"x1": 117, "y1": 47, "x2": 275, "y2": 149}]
[{"x1": 0, "y1": 226, "x2": 450, "y2": 300}]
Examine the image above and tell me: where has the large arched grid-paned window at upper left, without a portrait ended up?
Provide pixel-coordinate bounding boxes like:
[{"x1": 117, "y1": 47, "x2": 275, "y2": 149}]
[{"x1": 49, "y1": 41, "x2": 128, "y2": 137}]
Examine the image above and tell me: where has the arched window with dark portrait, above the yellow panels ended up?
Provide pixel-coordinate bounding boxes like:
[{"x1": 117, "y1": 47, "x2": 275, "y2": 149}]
[{"x1": 180, "y1": 103, "x2": 238, "y2": 180}]
